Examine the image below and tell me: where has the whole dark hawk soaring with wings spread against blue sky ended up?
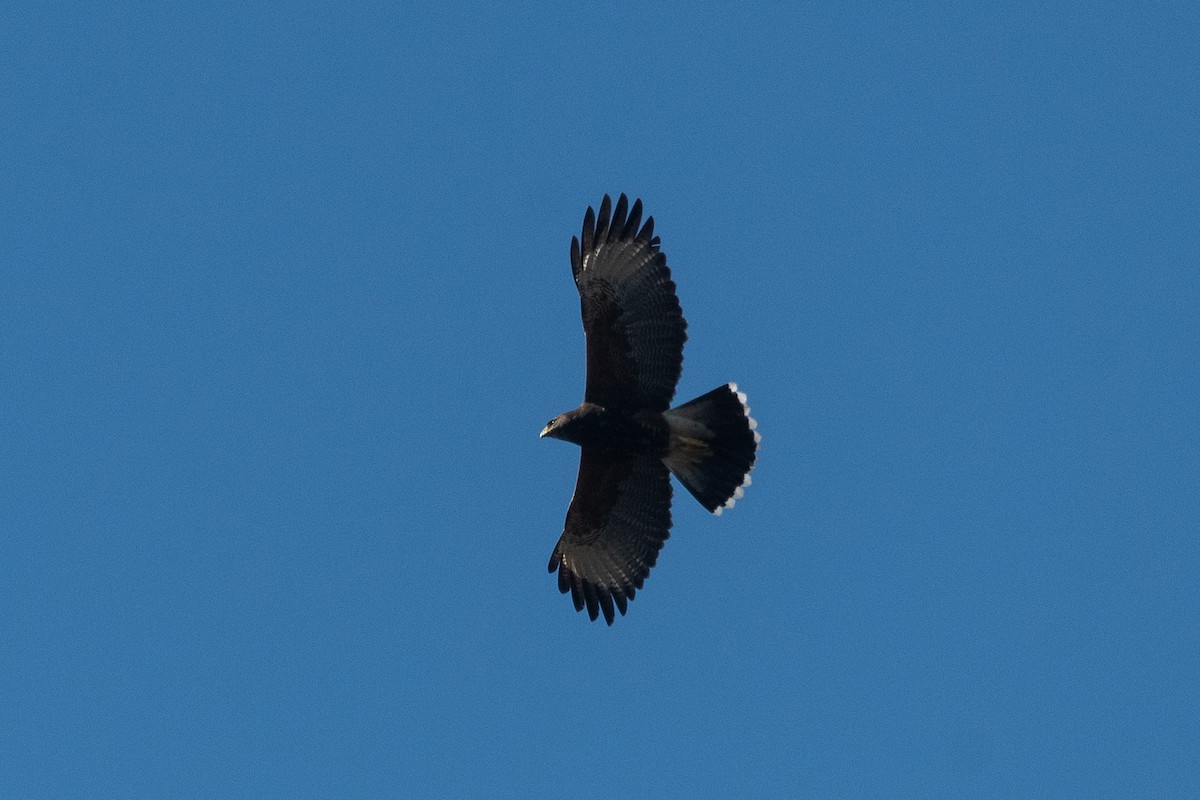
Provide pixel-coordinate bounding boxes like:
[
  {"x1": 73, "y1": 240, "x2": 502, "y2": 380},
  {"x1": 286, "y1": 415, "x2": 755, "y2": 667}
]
[{"x1": 541, "y1": 194, "x2": 761, "y2": 625}]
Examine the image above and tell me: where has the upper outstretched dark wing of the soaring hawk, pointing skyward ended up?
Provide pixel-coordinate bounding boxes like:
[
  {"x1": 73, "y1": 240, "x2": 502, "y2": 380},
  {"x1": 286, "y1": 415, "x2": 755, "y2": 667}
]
[{"x1": 571, "y1": 194, "x2": 688, "y2": 411}]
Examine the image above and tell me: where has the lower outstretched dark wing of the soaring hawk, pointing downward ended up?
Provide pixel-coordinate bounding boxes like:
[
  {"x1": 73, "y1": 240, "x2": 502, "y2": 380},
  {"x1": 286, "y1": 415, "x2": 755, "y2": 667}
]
[{"x1": 550, "y1": 447, "x2": 671, "y2": 625}]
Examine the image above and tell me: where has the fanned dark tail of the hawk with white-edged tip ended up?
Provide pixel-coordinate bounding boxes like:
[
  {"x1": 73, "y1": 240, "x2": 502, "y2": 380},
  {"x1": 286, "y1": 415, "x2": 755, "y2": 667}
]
[{"x1": 662, "y1": 384, "x2": 762, "y2": 515}]
